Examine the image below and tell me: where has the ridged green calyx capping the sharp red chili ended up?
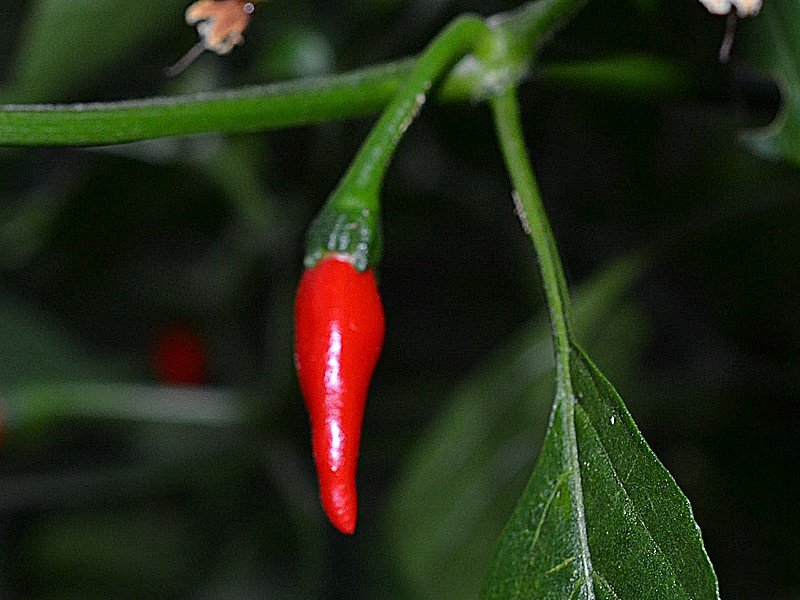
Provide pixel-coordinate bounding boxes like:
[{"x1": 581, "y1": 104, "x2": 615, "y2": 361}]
[{"x1": 303, "y1": 201, "x2": 383, "y2": 271}]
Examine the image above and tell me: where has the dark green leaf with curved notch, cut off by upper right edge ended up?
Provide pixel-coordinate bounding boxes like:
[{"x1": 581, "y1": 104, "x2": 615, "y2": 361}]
[{"x1": 742, "y1": 0, "x2": 800, "y2": 166}]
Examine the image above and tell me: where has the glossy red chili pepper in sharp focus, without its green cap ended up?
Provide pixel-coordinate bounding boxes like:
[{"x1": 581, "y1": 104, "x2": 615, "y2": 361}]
[{"x1": 295, "y1": 255, "x2": 385, "y2": 534}]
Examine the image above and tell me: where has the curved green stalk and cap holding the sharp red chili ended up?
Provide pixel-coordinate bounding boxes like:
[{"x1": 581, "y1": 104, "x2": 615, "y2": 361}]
[{"x1": 305, "y1": 16, "x2": 490, "y2": 271}]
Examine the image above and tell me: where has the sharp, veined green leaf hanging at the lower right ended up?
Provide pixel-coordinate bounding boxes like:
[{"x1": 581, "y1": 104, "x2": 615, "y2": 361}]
[{"x1": 483, "y1": 346, "x2": 719, "y2": 600}]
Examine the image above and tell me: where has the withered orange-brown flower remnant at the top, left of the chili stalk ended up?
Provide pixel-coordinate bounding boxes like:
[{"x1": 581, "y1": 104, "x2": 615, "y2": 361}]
[{"x1": 166, "y1": 0, "x2": 255, "y2": 77}]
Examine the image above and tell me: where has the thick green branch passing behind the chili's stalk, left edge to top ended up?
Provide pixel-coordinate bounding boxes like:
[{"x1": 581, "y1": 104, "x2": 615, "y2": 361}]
[{"x1": 0, "y1": 0, "x2": 586, "y2": 146}]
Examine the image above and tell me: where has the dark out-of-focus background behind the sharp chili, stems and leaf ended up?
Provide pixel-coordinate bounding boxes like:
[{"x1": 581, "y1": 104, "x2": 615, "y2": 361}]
[{"x1": 0, "y1": 0, "x2": 800, "y2": 599}]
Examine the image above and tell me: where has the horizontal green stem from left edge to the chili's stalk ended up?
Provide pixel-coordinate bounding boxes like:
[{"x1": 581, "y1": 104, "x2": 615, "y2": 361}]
[{"x1": 0, "y1": 61, "x2": 413, "y2": 146}]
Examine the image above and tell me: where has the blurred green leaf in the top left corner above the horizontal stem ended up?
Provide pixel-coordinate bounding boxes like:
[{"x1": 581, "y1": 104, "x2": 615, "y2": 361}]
[{"x1": 4, "y1": 0, "x2": 186, "y2": 102}]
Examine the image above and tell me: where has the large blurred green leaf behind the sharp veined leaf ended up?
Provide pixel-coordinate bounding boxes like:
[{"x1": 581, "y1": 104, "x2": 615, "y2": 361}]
[{"x1": 386, "y1": 259, "x2": 642, "y2": 598}]
